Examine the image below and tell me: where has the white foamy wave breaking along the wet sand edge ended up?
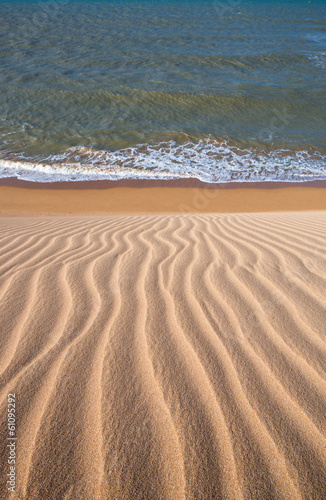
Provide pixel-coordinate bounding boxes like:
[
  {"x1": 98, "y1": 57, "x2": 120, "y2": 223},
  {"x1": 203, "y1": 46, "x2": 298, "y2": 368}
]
[{"x1": 0, "y1": 138, "x2": 326, "y2": 182}]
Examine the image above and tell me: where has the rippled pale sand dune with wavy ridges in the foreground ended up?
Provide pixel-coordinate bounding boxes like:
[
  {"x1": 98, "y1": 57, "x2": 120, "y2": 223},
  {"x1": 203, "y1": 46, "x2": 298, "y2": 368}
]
[{"x1": 0, "y1": 212, "x2": 326, "y2": 500}]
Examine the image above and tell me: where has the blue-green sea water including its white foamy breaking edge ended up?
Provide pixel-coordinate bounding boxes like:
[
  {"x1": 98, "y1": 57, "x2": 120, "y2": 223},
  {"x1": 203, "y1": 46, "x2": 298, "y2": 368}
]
[{"x1": 0, "y1": 0, "x2": 326, "y2": 182}]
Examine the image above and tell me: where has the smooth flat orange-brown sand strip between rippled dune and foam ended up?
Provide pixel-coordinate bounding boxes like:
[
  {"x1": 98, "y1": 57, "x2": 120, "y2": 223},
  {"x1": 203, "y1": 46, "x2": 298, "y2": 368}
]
[{"x1": 0, "y1": 178, "x2": 326, "y2": 215}]
